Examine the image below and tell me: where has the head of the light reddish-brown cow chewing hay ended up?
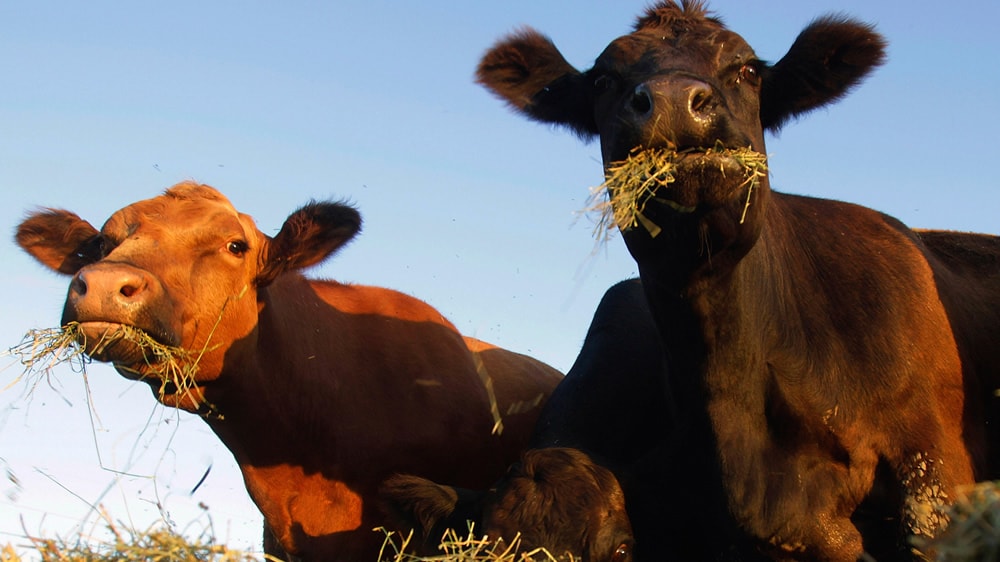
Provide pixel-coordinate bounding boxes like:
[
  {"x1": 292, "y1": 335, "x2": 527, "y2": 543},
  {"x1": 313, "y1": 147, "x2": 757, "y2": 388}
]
[{"x1": 16, "y1": 182, "x2": 361, "y2": 411}]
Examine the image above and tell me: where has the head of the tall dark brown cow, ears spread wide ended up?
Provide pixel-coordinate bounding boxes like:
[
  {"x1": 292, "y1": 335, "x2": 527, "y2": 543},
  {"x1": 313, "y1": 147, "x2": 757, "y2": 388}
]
[{"x1": 477, "y1": 0, "x2": 885, "y2": 280}]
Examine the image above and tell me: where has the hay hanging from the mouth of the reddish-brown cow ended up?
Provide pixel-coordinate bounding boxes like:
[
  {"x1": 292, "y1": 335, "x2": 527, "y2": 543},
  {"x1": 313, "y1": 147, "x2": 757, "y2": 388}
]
[{"x1": 10, "y1": 322, "x2": 204, "y2": 410}]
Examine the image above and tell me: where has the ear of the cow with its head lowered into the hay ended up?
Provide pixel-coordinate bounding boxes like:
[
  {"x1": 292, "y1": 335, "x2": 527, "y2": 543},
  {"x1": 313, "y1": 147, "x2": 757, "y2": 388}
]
[{"x1": 379, "y1": 474, "x2": 484, "y2": 546}]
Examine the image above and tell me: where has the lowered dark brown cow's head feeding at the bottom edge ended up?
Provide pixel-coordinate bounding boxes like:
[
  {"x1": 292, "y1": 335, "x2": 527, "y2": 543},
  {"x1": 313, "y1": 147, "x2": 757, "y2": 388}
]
[{"x1": 381, "y1": 447, "x2": 634, "y2": 562}]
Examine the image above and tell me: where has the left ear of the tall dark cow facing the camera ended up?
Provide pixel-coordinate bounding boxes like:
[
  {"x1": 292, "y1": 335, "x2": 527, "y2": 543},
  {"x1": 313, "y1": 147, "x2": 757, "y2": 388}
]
[{"x1": 476, "y1": 28, "x2": 597, "y2": 138}]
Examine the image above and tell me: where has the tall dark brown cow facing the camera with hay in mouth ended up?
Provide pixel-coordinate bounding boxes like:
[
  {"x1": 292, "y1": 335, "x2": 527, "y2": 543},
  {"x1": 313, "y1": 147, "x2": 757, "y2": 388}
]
[{"x1": 477, "y1": 0, "x2": 1000, "y2": 562}]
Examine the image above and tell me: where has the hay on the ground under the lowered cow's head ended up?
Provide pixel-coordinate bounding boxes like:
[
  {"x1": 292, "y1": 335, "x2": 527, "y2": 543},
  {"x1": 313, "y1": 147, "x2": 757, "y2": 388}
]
[{"x1": 375, "y1": 524, "x2": 576, "y2": 562}]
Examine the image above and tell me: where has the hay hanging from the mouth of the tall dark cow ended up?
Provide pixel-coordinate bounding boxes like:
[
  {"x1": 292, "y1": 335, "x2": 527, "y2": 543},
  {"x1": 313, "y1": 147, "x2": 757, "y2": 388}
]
[{"x1": 586, "y1": 144, "x2": 767, "y2": 243}]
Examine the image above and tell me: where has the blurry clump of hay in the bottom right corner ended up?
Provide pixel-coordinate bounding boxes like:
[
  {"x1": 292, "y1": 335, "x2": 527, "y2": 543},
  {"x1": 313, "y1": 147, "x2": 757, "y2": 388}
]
[{"x1": 912, "y1": 476, "x2": 1000, "y2": 562}]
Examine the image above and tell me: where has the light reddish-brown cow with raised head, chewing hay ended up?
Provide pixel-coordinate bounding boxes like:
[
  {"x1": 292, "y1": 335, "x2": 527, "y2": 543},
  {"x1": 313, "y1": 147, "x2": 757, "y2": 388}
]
[{"x1": 16, "y1": 182, "x2": 562, "y2": 561}]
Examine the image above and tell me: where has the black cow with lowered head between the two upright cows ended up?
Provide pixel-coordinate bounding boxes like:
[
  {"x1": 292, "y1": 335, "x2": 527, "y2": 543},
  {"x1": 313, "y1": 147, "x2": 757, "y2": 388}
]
[{"x1": 382, "y1": 279, "x2": 673, "y2": 562}]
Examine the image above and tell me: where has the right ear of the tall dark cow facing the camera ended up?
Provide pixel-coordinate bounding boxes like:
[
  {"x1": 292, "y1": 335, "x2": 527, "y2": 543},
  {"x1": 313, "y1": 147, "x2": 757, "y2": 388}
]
[{"x1": 760, "y1": 16, "x2": 886, "y2": 131}]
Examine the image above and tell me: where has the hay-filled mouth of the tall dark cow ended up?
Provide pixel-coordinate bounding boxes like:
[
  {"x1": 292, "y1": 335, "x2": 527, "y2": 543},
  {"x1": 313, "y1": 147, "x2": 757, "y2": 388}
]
[{"x1": 590, "y1": 144, "x2": 767, "y2": 237}]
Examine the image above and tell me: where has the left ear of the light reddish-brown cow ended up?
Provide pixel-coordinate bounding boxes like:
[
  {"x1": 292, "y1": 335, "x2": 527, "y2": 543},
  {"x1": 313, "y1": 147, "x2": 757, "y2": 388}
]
[{"x1": 14, "y1": 209, "x2": 101, "y2": 275}]
